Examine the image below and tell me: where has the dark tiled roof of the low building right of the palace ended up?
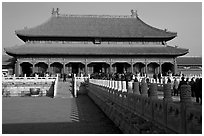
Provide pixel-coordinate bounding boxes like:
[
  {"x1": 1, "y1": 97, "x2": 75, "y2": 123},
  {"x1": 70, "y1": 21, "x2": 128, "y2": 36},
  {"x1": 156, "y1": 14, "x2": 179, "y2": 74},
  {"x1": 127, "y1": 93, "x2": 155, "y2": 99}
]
[{"x1": 177, "y1": 57, "x2": 202, "y2": 65}]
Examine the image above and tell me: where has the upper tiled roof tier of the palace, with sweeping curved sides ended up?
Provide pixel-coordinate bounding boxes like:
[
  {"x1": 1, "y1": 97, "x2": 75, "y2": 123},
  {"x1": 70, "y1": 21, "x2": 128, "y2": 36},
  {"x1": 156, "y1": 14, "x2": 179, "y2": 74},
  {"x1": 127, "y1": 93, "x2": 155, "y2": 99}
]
[{"x1": 16, "y1": 9, "x2": 177, "y2": 41}]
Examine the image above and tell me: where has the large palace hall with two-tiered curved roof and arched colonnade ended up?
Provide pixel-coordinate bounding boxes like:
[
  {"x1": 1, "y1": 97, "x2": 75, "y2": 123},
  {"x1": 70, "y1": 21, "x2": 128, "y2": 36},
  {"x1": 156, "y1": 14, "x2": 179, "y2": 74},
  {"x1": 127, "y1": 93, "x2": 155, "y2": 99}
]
[{"x1": 4, "y1": 8, "x2": 188, "y2": 76}]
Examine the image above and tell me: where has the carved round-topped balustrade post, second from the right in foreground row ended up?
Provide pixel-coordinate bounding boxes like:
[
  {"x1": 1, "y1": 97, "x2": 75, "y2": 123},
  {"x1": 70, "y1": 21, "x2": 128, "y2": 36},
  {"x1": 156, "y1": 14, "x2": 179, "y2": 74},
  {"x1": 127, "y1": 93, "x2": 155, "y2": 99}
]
[{"x1": 163, "y1": 83, "x2": 173, "y2": 102}]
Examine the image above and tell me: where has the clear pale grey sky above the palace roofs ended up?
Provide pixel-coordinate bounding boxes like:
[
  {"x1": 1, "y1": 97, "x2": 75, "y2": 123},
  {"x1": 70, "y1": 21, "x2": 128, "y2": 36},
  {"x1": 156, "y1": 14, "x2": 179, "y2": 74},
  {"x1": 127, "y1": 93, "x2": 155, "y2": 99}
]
[{"x1": 2, "y1": 2, "x2": 202, "y2": 56}]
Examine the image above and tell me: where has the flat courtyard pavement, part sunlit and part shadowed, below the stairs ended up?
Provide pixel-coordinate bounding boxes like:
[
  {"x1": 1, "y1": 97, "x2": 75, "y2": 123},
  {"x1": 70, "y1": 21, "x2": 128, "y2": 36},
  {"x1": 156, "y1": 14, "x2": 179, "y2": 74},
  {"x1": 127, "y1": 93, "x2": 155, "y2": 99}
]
[{"x1": 2, "y1": 95, "x2": 121, "y2": 134}]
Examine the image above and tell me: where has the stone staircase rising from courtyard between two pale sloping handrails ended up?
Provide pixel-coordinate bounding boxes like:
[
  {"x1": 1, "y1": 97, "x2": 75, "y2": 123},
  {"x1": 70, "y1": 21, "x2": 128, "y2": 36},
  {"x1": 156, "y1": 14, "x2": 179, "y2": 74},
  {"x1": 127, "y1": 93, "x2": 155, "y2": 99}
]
[{"x1": 56, "y1": 80, "x2": 73, "y2": 98}]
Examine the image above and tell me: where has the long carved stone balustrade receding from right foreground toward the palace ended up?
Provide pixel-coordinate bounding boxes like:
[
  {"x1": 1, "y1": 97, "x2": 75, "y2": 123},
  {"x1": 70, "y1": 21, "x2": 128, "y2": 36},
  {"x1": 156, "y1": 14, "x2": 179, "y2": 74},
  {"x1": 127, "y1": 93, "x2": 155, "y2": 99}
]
[{"x1": 88, "y1": 79, "x2": 202, "y2": 134}]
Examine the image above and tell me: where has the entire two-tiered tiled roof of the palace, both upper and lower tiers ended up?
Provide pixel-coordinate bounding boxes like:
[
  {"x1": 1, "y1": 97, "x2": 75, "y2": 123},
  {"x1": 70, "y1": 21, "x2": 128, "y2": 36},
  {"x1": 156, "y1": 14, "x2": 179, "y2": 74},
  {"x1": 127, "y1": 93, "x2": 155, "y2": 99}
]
[{"x1": 5, "y1": 10, "x2": 188, "y2": 56}]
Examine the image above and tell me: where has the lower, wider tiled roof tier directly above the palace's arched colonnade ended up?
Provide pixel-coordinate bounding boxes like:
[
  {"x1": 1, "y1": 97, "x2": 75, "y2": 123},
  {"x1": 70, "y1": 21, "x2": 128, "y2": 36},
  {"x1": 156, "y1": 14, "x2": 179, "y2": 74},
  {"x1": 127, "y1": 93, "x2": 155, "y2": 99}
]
[{"x1": 5, "y1": 43, "x2": 188, "y2": 56}]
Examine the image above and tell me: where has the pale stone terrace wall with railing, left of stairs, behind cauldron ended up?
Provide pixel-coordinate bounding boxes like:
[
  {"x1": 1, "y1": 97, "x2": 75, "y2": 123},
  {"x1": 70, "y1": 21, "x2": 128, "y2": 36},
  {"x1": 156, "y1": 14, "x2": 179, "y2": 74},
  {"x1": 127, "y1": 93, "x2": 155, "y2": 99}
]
[{"x1": 2, "y1": 76, "x2": 58, "y2": 97}]
